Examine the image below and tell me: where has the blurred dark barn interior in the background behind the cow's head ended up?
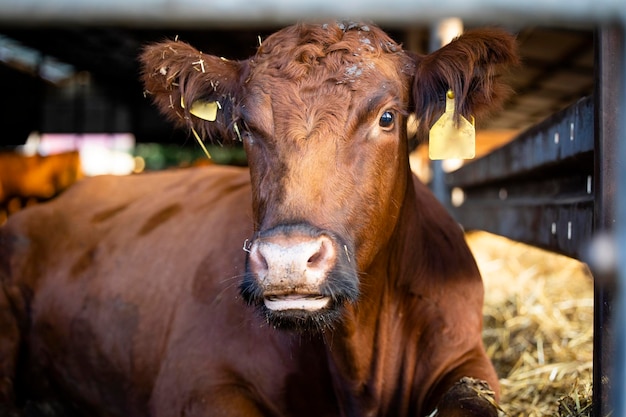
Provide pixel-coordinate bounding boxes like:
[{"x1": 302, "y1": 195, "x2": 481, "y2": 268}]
[{"x1": 0, "y1": 17, "x2": 594, "y2": 207}]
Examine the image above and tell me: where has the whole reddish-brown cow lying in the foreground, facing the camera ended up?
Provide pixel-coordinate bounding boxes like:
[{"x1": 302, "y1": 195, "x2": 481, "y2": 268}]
[{"x1": 0, "y1": 23, "x2": 517, "y2": 417}]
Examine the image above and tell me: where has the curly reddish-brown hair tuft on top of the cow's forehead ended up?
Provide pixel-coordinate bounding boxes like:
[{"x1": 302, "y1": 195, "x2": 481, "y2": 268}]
[{"x1": 253, "y1": 22, "x2": 402, "y2": 81}]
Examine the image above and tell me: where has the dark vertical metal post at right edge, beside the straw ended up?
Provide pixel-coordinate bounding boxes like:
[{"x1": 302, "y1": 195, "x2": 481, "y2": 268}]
[{"x1": 591, "y1": 26, "x2": 623, "y2": 417}]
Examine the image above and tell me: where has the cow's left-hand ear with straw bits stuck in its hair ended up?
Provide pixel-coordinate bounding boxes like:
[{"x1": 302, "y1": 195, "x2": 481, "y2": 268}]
[{"x1": 139, "y1": 41, "x2": 247, "y2": 140}]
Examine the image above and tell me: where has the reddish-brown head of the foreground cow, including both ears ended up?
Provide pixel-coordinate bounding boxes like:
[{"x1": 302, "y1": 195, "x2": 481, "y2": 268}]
[{"x1": 141, "y1": 23, "x2": 517, "y2": 329}]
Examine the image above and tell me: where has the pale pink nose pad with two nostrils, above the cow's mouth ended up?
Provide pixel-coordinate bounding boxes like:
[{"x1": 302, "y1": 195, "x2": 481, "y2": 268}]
[{"x1": 248, "y1": 235, "x2": 337, "y2": 292}]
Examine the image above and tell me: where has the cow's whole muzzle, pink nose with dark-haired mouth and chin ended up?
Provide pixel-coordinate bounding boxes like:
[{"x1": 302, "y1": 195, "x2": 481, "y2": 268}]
[{"x1": 241, "y1": 224, "x2": 358, "y2": 328}]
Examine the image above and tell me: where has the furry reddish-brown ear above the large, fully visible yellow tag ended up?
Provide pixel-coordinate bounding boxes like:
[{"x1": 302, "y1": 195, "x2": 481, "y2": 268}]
[{"x1": 413, "y1": 28, "x2": 519, "y2": 128}]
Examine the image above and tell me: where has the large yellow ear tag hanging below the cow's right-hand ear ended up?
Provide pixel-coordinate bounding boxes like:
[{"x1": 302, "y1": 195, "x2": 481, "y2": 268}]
[{"x1": 428, "y1": 90, "x2": 476, "y2": 159}]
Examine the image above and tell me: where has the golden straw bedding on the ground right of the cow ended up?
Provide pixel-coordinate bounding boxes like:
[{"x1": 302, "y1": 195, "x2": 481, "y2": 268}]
[{"x1": 467, "y1": 232, "x2": 593, "y2": 417}]
